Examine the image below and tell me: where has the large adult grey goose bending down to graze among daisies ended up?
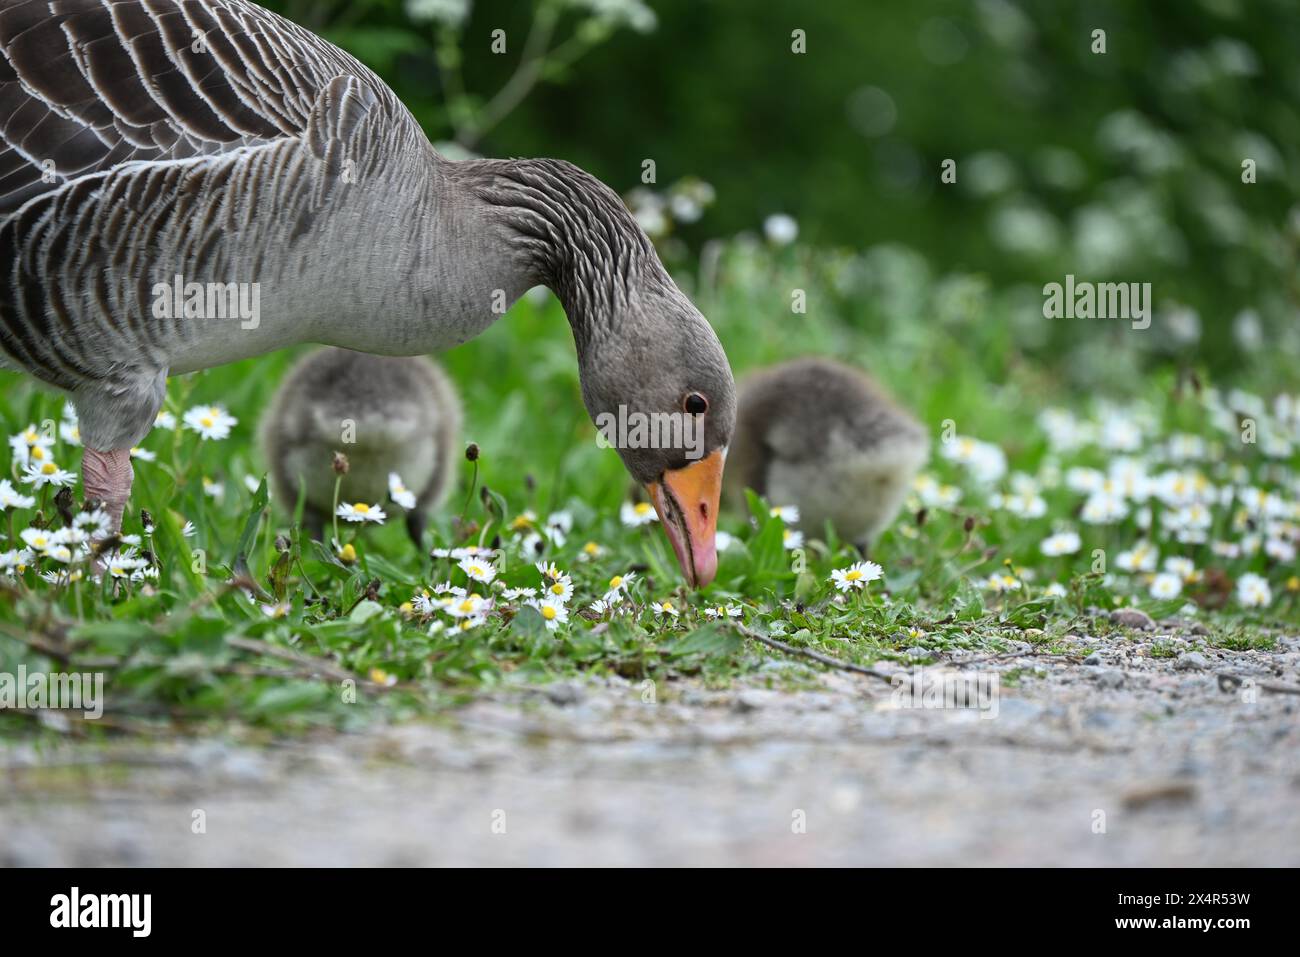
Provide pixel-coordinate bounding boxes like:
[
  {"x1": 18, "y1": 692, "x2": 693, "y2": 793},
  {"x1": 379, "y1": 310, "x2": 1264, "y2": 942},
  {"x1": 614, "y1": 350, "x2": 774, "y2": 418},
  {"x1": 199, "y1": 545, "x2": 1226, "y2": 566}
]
[{"x1": 0, "y1": 0, "x2": 735, "y2": 585}]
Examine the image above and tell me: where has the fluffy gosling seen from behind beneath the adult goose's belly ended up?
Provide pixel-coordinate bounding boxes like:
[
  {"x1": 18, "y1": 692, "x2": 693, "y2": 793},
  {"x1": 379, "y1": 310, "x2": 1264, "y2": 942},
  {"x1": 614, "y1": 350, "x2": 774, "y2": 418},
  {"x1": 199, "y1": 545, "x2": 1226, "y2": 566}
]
[{"x1": 260, "y1": 348, "x2": 460, "y2": 546}]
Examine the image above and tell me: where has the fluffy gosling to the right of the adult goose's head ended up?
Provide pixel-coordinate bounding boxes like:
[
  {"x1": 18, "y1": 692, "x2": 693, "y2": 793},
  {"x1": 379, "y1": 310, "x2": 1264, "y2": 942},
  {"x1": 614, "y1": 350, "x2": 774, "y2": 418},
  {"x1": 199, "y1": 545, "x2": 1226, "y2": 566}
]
[{"x1": 727, "y1": 358, "x2": 930, "y2": 551}]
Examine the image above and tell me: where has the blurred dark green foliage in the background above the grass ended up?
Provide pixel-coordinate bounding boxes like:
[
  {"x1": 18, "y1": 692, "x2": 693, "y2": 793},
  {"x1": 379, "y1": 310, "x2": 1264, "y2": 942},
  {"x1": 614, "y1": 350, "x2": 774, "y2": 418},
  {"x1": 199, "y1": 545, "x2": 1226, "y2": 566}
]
[{"x1": 268, "y1": 0, "x2": 1300, "y2": 369}]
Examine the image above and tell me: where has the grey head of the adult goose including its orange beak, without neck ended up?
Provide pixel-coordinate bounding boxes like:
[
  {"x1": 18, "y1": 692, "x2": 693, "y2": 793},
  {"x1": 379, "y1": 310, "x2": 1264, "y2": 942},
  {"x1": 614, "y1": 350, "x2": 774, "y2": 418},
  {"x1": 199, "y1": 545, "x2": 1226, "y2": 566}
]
[{"x1": 579, "y1": 277, "x2": 736, "y2": 588}]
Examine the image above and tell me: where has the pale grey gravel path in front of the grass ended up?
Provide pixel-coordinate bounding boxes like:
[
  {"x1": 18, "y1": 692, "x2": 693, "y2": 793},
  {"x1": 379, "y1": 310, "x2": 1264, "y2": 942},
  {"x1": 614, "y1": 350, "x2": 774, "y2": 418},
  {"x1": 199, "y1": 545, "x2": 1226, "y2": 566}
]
[{"x1": 0, "y1": 635, "x2": 1300, "y2": 866}]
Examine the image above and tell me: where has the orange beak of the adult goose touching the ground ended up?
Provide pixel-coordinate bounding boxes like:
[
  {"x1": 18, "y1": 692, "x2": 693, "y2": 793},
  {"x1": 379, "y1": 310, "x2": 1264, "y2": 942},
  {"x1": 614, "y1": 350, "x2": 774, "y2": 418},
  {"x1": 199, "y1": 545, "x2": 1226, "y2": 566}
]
[{"x1": 646, "y1": 450, "x2": 724, "y2": 588}]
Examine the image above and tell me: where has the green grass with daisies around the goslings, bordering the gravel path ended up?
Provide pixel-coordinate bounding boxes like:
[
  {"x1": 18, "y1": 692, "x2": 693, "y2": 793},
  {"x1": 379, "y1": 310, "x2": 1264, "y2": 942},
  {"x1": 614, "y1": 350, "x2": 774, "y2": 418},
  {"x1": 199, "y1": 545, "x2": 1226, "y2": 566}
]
[{"x1": 0, "y1": 242, "x2": 1300, "y2": 733}]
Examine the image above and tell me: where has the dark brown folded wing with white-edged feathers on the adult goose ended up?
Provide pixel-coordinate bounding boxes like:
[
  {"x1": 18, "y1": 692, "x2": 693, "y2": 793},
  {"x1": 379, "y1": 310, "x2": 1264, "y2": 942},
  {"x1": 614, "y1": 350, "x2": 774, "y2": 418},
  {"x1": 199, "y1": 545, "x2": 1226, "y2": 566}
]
[{"x1": 0, "y1": 0, "x2": 404, "y2": 220}]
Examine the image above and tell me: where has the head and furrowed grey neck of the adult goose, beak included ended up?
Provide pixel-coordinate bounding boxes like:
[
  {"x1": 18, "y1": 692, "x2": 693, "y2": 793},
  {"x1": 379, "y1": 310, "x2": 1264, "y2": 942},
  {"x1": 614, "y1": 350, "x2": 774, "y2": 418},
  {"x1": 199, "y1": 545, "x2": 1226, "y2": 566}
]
[{"x1": 465, "y1": 160, "x2": 736, "y2": 588}]
